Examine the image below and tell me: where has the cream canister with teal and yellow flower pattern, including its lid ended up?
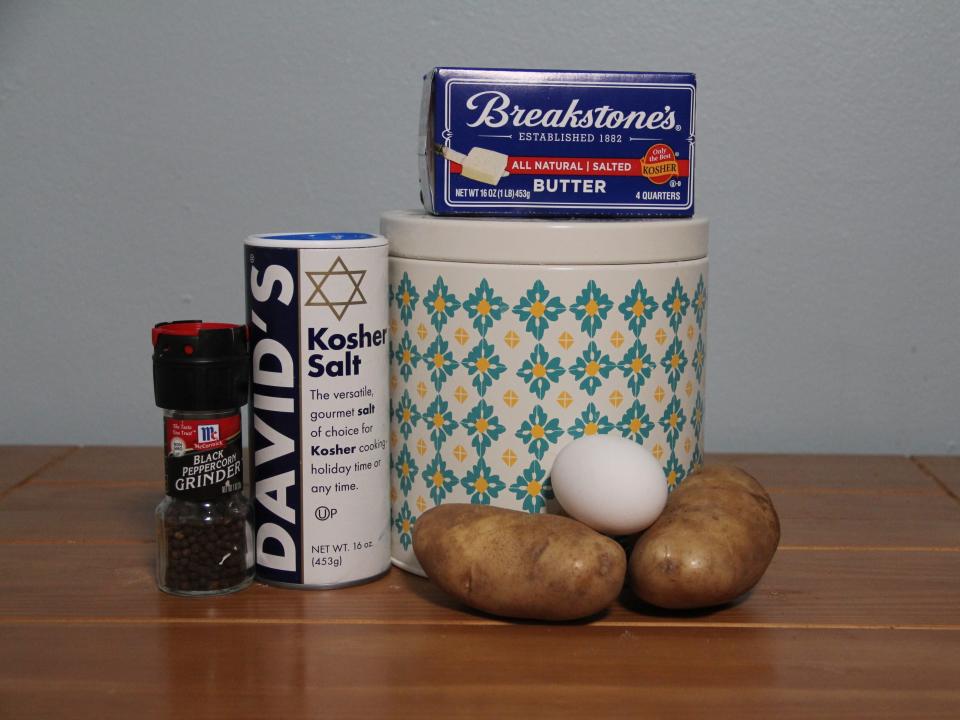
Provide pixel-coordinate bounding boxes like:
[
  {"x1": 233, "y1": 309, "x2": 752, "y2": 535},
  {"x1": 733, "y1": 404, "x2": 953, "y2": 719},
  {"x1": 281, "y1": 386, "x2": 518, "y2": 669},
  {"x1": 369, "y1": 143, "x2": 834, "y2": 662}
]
[{"x1": 381, "y1": 211, "x2": 707, "y2": 574}]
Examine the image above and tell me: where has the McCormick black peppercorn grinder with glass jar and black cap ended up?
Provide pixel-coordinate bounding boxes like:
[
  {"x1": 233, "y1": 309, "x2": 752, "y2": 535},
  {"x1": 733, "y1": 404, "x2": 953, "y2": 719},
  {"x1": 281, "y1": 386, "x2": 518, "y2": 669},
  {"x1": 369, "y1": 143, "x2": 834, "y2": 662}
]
[{"x1": 152, "y1": 320, "x2": 254, "y2": 596}]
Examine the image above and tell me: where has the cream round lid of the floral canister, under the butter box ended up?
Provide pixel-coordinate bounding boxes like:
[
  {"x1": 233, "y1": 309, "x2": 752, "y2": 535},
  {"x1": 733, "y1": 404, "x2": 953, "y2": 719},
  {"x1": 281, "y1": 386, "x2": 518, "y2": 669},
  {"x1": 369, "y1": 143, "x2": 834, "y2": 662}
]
[{"x1": 380, "y1": 210, "x2": 708, "y2": 265}]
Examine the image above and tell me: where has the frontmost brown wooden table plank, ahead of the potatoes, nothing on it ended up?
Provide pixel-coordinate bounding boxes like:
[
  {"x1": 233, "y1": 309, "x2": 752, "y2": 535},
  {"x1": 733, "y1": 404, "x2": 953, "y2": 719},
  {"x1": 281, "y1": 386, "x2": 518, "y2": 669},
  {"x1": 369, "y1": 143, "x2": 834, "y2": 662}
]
[{"x1": 0, "y1": 623, "x2": 960, "y2": 720}]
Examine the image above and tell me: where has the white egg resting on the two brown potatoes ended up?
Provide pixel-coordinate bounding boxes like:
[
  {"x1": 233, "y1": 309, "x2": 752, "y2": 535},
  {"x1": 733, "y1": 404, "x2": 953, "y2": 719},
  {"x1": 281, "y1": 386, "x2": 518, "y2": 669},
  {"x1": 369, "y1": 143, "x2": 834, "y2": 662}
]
[{"x1": 550, "y1": 435, "x2": 668, "y2": 535}]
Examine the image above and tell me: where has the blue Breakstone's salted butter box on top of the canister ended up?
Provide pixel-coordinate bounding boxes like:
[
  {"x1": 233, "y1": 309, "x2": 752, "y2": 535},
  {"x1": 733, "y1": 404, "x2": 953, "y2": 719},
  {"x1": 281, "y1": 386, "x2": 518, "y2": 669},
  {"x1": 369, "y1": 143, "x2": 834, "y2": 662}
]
[{"x1": 420, "y1": 67, "x2": 697, "y2": 217}]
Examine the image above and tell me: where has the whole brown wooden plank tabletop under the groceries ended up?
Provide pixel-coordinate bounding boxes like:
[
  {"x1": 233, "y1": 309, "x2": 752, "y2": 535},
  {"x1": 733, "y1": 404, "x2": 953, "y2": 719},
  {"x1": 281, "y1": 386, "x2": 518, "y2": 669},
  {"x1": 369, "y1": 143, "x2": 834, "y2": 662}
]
[{"x1": 0, "y1": 446, "x2": 960, "y2": 720}]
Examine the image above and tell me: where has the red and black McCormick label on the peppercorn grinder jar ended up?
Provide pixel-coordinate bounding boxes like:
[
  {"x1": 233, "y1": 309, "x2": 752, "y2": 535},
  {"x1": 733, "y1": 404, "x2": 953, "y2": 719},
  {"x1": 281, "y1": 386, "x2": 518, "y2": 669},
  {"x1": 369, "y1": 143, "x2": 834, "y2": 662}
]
[{"x1": 163, "y1": 413, "x2": 243, "y2": 502}]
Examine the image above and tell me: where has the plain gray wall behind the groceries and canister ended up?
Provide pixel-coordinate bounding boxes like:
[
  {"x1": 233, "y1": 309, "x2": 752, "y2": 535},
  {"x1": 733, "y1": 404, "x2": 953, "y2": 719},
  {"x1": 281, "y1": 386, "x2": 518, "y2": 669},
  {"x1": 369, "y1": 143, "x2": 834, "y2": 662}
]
[{"x1": 0, "y1": 0, "x2": 960, "y2": 453}]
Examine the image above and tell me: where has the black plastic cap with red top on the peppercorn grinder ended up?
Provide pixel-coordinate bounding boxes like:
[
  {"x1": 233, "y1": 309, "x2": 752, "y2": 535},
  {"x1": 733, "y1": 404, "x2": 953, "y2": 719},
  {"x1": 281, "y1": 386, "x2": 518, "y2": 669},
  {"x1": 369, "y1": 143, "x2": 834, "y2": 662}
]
[{"x1": 152, "y1": 320, "x2": 250, "y2": 411}]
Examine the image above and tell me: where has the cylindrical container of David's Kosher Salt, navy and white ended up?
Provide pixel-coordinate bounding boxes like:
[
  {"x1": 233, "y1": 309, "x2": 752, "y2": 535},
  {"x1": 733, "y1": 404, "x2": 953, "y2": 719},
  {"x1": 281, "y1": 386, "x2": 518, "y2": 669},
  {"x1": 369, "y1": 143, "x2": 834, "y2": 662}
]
[{"x1": 245, "y1": 233, "x2": 390, "y2": 588}]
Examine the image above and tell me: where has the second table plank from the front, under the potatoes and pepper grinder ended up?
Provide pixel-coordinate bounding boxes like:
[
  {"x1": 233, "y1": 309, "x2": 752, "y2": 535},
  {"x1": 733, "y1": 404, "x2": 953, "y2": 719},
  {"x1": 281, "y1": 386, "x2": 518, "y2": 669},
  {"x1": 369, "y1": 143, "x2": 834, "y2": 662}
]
[{"x1": 0, "y1": 544, "x2": 960, "y2": 630}]
